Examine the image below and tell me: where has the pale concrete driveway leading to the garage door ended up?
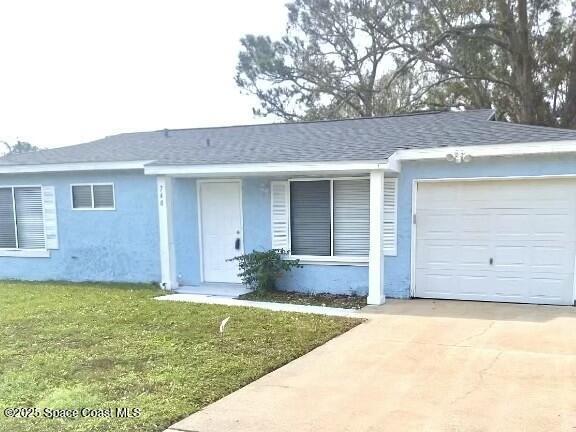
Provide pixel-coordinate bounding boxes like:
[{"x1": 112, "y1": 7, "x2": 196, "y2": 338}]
[{"x1": 169, "y1": 300, "x2": 576, "y2": 432}]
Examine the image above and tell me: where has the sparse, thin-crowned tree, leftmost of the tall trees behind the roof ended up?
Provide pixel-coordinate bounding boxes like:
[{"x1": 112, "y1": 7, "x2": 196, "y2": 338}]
[{"x1": 236, "y1": 0, "x2": 408, "y2": 121}]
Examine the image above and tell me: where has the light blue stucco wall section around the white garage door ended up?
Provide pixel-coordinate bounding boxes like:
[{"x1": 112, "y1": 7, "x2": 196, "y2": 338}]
[{"x1": 384, "y1": 155, "x2": 576, "y2": 297}]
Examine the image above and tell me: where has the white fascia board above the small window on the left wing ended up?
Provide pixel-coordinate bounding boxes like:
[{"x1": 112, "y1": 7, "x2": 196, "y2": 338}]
[{"x1": 0, "y1": 161, "x2": 152, "y2": 174}]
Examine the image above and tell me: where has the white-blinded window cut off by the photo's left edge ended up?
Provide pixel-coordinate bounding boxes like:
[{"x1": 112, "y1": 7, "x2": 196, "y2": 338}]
[{"x1": 0, "y1": 186, "x2": 46, "y2": 249}]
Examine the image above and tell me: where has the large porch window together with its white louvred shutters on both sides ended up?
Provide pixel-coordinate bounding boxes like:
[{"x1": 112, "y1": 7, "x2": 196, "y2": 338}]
[{"x1": 270, "y1": 177, "x2": 398, "y2": 263}]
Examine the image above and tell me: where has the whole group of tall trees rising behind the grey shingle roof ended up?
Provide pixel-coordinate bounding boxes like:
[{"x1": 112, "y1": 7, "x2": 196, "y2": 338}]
[{"x1": 236, "y1": 0, "x2": 576, "y2": 127}]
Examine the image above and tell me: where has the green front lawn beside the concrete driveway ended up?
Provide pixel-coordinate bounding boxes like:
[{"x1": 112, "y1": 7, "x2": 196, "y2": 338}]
[{"x1": 0, "y1": 282, "x2": 359, "y2": 432}]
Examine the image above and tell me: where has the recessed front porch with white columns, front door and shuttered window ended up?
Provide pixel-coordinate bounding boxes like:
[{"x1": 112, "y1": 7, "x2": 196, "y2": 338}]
[{"x1": 154, "y1": 163, "x2": 397, "y2": 304}]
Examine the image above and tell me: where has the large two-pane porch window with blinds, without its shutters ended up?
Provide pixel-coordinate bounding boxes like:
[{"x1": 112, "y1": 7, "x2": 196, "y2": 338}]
[{"x1": 290, "y1": 179, "x2": 370, "y2": 257}]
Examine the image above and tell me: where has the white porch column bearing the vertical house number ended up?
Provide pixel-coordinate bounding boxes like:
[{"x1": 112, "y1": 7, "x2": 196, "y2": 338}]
[{"x1": 156, "y1": 176, "x2": 178, "y2": 290}]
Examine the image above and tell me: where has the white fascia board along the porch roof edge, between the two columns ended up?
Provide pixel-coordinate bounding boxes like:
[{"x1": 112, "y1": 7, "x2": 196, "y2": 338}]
[{"x1": 144, "y1": 161, "x2": 388, "y2": 176}]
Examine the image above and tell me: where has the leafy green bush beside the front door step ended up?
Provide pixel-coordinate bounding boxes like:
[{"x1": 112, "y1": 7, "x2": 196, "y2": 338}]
[{"x1": 229, "y1": 249, "x2": 302, "y2": 292}]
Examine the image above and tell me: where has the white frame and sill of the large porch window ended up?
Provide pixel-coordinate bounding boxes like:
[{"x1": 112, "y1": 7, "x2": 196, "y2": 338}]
[{"x1": 288, "y1": 176, "x2": 370, "y2": 267}]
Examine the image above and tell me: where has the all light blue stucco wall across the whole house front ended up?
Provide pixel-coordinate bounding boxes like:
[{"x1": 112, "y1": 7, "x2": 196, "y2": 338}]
[{"x1": 6, "y1": 155, "x2": 576, "y2": 298}]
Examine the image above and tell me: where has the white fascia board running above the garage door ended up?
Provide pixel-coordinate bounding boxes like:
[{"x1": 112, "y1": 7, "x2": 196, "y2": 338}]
[{"x1": 388, "y1": 140, "x2": 576, "y2": 163}]
